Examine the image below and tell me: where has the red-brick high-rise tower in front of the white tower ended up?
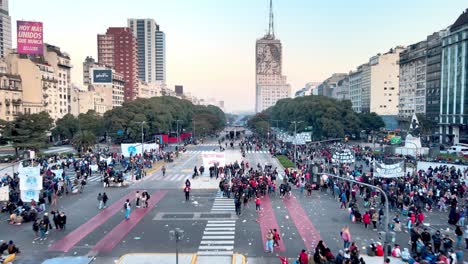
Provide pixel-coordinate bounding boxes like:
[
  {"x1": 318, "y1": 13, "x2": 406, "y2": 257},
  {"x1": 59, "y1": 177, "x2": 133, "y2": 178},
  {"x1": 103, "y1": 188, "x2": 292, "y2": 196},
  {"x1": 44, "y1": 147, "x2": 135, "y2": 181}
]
[{"x1": 97, "y1": 27, "x2": 138, "y2": 101}]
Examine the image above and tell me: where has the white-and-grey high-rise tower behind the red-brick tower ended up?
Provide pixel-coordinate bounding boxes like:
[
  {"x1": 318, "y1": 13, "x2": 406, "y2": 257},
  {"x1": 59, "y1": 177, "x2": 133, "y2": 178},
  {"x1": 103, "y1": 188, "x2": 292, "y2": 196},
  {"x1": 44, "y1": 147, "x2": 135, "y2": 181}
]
[{"x1": 127, "y1": 18, "x2": 166, "y2": 83}]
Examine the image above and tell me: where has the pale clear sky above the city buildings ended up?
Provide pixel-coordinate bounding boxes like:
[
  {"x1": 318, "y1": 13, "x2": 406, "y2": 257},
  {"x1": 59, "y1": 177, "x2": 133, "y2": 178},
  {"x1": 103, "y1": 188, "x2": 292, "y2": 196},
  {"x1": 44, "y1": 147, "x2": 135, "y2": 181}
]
[{"x1": 9, "y1": 0, "x2": 468, "y2": 112}]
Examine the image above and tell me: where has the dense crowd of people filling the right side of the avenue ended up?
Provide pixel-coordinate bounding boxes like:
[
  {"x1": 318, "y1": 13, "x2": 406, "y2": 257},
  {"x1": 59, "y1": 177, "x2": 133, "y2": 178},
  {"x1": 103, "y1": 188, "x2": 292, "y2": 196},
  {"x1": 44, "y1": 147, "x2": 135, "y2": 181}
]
[{"x1": 215, "y1": 137, "x2": 468, "y2": 263}]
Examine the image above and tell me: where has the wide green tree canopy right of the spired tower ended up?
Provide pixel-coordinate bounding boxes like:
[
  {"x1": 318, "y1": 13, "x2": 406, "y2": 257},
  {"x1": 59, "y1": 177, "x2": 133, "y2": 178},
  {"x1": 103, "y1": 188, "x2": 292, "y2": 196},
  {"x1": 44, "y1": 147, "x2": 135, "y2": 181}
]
[{"x1": 247, "y1": 95, "x2": 384, "y2": 139}]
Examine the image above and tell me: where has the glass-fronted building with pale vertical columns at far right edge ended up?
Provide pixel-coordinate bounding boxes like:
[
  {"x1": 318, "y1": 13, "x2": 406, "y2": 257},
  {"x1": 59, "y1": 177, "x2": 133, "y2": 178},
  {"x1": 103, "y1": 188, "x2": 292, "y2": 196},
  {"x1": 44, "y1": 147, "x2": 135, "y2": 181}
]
[{"x1": 439, "y1": 9, "x2": 468, "y2": 143}]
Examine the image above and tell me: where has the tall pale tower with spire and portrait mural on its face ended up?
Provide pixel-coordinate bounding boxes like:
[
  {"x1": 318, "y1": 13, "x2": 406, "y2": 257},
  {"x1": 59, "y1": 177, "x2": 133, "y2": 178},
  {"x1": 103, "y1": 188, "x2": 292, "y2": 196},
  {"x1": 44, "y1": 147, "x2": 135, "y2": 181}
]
[{"x1": 255, "y1": 0, "x2": 291, "y2": 112}]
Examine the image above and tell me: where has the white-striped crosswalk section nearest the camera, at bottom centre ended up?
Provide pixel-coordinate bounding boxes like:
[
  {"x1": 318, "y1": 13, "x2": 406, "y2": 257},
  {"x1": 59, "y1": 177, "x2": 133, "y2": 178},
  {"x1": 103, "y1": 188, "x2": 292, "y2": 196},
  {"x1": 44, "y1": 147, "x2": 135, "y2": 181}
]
[{"x1": 197, "y1": 220, "x2": 236, "y2": 256}]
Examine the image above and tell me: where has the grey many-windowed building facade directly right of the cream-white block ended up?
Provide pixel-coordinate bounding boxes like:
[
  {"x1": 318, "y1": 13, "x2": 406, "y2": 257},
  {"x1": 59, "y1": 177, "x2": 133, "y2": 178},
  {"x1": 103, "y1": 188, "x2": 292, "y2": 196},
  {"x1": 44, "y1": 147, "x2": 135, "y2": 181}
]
[{"x1": 398, "y1": 41, "x2": 427, "y2": 120}]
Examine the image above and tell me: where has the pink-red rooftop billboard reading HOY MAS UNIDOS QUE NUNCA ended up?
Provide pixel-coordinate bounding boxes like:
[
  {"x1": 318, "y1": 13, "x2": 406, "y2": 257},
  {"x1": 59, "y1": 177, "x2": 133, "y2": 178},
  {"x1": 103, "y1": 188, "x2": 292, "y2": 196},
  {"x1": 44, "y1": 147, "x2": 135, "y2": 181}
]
[{"x1": 16, "y1": 21, "x2": 44, "y2": 55}]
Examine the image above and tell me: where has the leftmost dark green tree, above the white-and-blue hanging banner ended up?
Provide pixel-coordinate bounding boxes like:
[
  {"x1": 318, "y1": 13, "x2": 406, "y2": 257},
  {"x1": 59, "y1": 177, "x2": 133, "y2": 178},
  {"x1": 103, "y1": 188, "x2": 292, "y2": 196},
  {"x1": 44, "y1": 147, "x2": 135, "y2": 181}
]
[{"x1": 6, "y1": 112, "x2": 53, "y2": 156}]
